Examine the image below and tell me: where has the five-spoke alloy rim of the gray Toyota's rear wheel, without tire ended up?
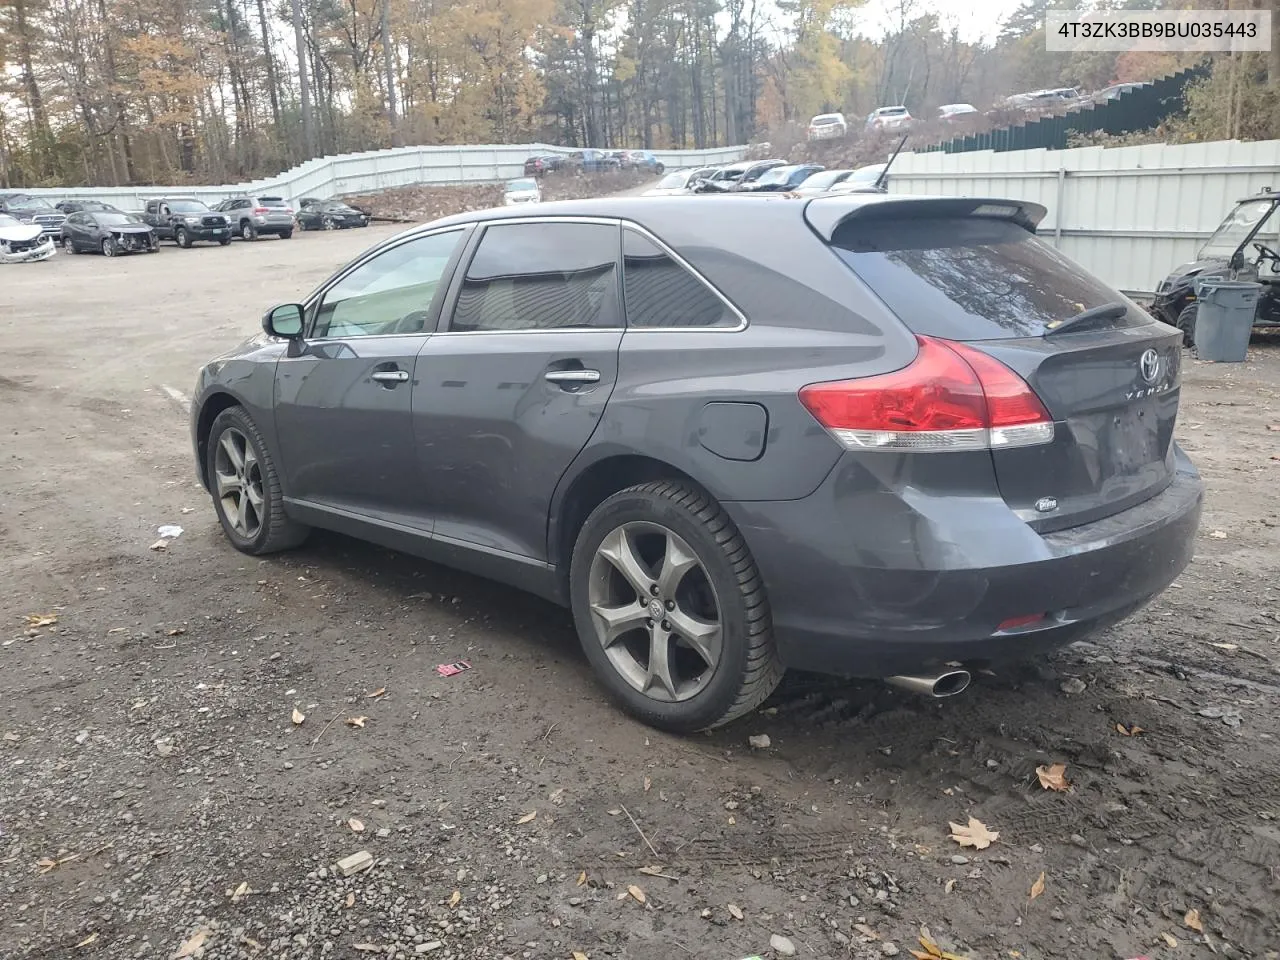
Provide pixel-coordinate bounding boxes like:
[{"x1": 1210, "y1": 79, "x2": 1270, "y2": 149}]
[{"x1": 588, "y1": 521, "x2": 723, "y2": 703}]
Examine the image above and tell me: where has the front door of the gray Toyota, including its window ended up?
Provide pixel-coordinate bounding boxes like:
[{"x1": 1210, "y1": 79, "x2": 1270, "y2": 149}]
[{"x1": 275, "y1": 229, "x2": 465, "y2": 530}]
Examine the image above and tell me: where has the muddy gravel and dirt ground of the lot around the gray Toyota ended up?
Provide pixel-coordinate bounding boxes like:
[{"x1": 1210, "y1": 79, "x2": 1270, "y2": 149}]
[{"x1": 0, "y1": 220, "x2": 1280, "y2": 960}]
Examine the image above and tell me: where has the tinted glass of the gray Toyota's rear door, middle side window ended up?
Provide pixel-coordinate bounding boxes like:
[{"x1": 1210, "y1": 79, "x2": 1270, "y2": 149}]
[{"x1": 449, "y1": 223, "x2": 622, "y2": 332}]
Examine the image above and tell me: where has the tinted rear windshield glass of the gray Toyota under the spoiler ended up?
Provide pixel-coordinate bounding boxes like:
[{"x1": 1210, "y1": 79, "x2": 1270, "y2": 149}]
[{"x1": 832, "y1": 218, "x2": 1151, "y2": 340}]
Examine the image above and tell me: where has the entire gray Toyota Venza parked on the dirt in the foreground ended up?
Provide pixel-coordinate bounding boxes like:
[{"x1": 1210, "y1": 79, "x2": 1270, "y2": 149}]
[{"x1": 192, "y1": 195, "x2": 1203, "y2": 731}]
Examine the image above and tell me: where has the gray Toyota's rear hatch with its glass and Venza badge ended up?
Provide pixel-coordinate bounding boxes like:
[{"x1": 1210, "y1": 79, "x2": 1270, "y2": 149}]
[{"x1": 810, "y1": 201, "x2": 1181, "y2": 532}]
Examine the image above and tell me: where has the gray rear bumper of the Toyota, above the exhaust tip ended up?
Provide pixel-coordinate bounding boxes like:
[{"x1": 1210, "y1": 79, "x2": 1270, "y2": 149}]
[{"x1": 724, "y1": 451, "x2": 1204, "y2": 677}]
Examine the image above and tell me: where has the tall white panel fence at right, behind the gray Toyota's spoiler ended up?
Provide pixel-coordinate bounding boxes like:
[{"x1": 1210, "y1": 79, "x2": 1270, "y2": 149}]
[{"x1": 890, "y1": 140, "x2": 1280, "y2": 293}]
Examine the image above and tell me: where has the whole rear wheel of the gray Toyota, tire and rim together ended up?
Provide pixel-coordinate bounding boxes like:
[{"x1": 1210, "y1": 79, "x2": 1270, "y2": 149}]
[{"x1": 570, "y1": 480, "x2": 783, "y2": 733}]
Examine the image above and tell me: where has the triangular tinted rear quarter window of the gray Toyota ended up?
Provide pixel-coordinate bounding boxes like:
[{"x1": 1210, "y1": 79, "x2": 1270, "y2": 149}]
[{"x1": 622, "y1": 230, "x2": 739, "y2": 328}]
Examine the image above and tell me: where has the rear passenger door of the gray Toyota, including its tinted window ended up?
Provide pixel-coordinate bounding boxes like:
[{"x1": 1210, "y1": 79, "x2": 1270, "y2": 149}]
[{"x1": 413, "y1": 220, "x2": 622, "y2": 561}]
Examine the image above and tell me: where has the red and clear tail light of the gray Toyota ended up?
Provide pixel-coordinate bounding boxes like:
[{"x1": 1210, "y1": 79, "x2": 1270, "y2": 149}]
[{"x1": 800, "y1": 337, "x2": 1053, "y2": 453}]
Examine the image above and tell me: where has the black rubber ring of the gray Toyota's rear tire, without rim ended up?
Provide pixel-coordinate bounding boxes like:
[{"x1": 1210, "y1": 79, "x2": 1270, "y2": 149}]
[{"x1": 570, "y1": 490, "x2": 749, "y2": 732}]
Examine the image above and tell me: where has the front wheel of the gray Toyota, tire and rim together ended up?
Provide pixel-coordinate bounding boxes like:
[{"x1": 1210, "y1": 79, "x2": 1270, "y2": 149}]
[{"x1": 205, "y1": 407, "x2": 310, "y2": 557}]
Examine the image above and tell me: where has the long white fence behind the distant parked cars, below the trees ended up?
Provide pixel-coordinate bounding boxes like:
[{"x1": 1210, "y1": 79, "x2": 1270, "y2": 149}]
[{"x1": 22, "y1": 143, "x2": 746, "y2": 210}]
